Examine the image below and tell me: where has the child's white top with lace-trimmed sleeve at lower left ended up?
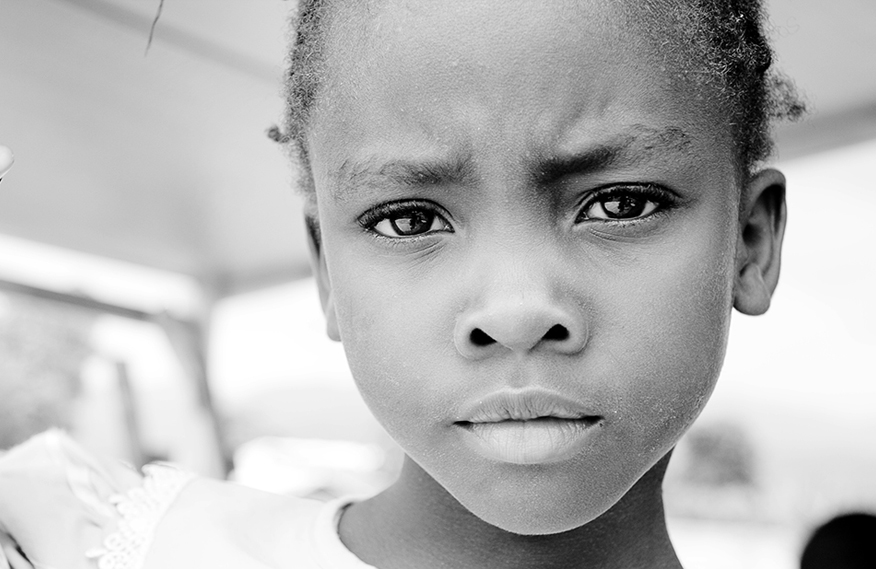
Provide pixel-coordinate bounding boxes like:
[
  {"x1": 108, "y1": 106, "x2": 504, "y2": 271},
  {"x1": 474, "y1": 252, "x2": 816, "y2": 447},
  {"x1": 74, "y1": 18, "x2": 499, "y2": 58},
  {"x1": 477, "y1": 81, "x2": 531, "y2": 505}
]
[{"x1": 0, "y1": 431, "x2": 374, "y2": 569}]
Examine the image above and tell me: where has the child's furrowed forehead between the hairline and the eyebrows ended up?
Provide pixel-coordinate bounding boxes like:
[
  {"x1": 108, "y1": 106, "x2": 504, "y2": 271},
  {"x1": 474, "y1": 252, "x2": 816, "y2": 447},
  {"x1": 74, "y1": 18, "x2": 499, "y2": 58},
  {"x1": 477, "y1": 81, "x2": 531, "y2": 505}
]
[{"x1": 309, "y1": 0, "x2": 726, "y2": 191}]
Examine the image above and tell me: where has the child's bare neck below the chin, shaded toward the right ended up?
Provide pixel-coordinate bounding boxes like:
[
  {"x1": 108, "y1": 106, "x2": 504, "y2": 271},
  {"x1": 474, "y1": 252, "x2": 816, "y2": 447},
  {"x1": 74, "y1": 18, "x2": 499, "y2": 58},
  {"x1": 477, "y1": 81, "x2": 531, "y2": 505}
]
[{"x1": 340, "y1": 455, "x2": 681, "y2": 569}]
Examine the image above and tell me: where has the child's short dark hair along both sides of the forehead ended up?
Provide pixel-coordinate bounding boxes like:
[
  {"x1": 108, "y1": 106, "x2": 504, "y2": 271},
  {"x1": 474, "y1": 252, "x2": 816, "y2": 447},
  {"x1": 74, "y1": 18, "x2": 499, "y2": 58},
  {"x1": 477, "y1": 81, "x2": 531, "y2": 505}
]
[{"x1": 278, "y1": 0, "x2": 804, "y2": 204}]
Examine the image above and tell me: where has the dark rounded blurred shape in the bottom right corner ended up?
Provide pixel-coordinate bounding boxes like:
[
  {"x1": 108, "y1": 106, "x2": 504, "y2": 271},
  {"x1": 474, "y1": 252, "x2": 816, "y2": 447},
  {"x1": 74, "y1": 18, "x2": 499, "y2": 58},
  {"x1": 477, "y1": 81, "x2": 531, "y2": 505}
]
[{"x1": 800, "y1": 513, "x2": 876, "y2": 569}]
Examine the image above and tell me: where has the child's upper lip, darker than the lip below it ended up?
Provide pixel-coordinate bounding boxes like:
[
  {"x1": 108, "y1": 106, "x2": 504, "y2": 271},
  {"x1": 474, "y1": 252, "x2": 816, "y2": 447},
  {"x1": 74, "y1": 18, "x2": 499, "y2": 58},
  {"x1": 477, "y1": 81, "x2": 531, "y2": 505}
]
[{"x1": 456, "y1": 388, "x2": 601, "y2": 423}]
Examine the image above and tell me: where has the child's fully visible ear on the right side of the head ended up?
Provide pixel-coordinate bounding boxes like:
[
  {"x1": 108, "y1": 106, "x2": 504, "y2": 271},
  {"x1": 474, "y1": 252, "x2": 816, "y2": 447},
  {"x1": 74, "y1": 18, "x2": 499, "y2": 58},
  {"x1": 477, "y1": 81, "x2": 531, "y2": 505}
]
[{"x1": 733, "y1": 168, "x2": 787, "y2": 316}]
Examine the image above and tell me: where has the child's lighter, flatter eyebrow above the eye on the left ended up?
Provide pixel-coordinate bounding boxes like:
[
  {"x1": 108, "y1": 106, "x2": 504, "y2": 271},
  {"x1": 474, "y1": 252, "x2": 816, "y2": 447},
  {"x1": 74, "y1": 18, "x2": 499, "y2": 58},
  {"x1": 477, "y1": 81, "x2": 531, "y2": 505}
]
[{"x1": 332, "y1": 155, "x2": 475, "y2": 201}]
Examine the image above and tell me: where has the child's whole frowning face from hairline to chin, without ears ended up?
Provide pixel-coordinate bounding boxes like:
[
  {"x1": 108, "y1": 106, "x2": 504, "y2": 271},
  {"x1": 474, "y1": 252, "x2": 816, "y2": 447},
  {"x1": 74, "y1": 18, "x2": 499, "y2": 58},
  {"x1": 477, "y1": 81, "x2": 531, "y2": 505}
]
[{"x1": 309, "y1": 0, "x2": 752, "y2": 534}]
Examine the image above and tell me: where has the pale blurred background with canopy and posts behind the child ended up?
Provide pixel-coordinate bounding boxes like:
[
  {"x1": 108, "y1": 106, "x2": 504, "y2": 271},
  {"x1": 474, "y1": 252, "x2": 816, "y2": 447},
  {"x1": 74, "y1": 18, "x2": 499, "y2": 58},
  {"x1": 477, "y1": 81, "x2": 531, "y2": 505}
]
[{"x1": 0, "y1": 0, "x2": 876, "y2": 569}]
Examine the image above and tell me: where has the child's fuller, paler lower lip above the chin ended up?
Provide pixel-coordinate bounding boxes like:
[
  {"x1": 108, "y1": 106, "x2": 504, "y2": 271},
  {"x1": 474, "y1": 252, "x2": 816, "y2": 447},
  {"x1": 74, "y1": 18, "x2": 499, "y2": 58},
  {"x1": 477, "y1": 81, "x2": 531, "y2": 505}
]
[{"x1": 457, "y1": 417, "x2": 599, "y2": 464}]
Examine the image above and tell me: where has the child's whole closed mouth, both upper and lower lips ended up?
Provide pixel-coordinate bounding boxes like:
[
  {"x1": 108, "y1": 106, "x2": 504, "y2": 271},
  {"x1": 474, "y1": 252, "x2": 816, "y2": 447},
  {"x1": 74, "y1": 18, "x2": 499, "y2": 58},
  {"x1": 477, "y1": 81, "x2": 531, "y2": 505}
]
[{"x1": 454, "y1": 389, "x2": 603, "y2": 464}]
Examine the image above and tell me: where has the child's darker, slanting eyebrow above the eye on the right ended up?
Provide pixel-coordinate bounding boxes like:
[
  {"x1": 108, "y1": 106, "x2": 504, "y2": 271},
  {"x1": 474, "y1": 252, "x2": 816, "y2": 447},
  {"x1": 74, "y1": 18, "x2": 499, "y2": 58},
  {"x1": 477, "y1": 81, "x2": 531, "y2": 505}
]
[{"x1": 532, "y1": 125, "x2": 691, "y2": 185}]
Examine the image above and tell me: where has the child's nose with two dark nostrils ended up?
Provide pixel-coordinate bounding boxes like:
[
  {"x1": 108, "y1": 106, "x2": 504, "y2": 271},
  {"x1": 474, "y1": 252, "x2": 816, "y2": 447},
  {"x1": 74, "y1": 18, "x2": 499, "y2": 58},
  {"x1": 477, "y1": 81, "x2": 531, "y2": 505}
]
[{"x1": 455, "y1": 233, "x2": 587, "y2": 358}]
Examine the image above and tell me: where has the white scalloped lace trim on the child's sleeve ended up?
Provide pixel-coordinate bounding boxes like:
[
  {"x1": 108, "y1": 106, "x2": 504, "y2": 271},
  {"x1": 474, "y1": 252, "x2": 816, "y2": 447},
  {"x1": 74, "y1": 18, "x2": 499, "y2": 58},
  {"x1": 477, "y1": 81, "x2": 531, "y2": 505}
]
[{"x1": 85, "y1": 464, "x2": 195, "y2": 569}]
